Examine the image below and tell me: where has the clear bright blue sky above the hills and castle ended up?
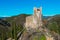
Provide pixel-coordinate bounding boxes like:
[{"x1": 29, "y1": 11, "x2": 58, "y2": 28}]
[{"x1": 0, "y1": 0, "x2": 60, "y2": 17}]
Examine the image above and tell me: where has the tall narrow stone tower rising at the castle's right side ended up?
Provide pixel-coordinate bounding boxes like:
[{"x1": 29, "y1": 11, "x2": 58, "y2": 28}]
[{"x1": 34, "y1": 7, "x2": 42, "y2": 27}]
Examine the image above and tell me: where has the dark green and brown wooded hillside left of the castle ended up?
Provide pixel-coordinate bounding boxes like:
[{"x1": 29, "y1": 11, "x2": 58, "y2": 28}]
[{"x1": 0, "y1": 14, "x2": 29, "y2": 40}]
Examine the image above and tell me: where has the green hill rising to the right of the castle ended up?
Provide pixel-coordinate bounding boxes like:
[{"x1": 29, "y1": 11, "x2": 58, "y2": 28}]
[{"x1": 47, "y1": 15, "x2": 60, "y2": 34}]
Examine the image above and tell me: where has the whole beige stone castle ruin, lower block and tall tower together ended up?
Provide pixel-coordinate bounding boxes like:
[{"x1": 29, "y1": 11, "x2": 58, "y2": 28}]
[{"x1": 25, "y1": 7, "x2": 42, "y2": 30}]
